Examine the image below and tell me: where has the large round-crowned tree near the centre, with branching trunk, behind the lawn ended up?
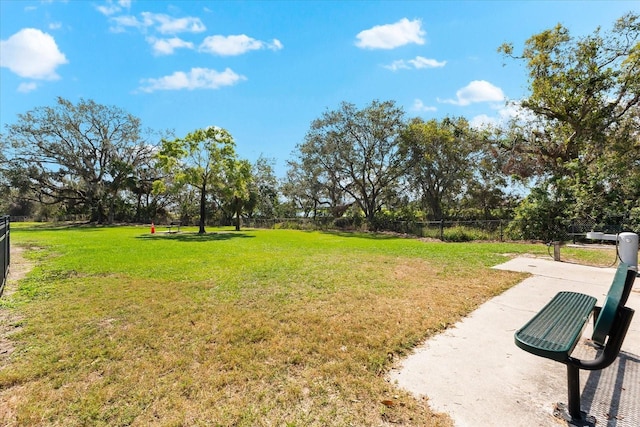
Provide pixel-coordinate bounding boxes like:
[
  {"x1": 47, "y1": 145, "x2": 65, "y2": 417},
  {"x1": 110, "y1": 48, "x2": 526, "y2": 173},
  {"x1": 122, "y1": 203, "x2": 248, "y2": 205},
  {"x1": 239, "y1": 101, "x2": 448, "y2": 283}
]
[{"x1": 298, "y1": 101, "x2": 404, "y2": 224}]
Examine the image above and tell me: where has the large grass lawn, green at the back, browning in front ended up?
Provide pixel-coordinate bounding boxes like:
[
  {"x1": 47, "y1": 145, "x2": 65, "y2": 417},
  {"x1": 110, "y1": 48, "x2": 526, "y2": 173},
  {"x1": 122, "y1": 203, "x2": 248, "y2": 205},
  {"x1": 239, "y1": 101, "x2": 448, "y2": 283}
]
[{"x1": 0, "y1": 223, "x2": 612, "y2": 426}]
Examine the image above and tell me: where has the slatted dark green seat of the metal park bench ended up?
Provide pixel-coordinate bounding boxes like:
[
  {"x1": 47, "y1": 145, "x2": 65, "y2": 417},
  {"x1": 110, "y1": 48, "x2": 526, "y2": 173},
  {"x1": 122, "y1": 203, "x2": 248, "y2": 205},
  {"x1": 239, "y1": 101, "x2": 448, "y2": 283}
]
[{"x1": 515, "y1": 292, "x2": 597, "y2": 362}]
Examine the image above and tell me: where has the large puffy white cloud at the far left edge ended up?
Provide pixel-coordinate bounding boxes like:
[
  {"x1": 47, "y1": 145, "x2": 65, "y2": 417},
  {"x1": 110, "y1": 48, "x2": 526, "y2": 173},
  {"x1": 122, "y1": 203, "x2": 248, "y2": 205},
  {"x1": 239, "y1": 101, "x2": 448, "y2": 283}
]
[{"x1": 0, "y1": 28, "x2": 68, "y2": 80}]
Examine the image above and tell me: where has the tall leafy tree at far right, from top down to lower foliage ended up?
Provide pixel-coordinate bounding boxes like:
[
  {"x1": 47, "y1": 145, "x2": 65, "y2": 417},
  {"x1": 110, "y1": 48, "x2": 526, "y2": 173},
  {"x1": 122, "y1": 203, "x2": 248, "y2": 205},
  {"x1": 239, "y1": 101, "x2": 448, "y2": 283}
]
[{"x1": 500, "y1": 13, "x2": 640, "y2": 237}]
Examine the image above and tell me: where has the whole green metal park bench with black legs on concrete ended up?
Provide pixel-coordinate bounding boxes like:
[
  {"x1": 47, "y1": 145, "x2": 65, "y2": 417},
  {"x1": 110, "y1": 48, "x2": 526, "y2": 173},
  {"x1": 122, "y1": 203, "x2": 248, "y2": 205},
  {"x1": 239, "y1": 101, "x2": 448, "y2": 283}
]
[{"x1": 515, "y1": 263, "x2": 636, "y2": 425}]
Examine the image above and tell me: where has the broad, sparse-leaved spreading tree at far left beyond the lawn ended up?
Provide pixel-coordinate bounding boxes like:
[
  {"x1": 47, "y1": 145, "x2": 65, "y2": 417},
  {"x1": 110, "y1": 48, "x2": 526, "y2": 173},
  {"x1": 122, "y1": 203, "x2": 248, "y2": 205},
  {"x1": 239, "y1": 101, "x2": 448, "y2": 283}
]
[{"x1": 6, "y1": 98, "x2": 153, "y2": 222}]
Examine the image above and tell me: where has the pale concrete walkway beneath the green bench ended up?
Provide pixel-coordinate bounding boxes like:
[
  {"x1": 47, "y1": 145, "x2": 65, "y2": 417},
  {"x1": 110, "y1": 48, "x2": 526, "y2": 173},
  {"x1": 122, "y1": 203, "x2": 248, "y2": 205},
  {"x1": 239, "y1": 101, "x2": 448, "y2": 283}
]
[{"x1": 390, "y1": 258, "x2": 640, "y2": 427}]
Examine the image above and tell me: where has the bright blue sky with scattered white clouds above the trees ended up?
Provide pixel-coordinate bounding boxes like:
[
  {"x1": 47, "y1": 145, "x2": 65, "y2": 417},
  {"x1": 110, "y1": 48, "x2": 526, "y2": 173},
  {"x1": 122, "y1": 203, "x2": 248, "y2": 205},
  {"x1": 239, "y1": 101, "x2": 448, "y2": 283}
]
[{"x1": 0, "y1": 0, "x2": 640, "y2": 176}]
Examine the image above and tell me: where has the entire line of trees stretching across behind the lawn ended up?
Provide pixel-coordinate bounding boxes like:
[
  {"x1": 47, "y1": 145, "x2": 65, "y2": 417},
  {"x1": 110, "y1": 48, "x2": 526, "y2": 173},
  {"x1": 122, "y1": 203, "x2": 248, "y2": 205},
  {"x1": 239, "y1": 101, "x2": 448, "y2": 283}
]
[{"x1": 0, "y1": 13, "x2": 640, "y2": 239}]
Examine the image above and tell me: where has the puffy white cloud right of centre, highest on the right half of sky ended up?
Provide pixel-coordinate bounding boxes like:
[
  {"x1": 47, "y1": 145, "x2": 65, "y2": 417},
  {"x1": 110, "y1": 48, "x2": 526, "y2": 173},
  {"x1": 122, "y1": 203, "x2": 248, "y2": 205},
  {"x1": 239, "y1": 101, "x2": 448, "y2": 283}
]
[{"x1": 356, "y1": 18, "x2": 426, "y2": 49}]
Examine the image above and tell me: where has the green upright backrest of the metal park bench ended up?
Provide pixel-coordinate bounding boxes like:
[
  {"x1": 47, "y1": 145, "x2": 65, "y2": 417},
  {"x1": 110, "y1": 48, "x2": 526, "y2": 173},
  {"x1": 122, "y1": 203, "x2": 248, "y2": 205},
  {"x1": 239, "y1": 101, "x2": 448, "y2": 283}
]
[{"x1": 591, "y1": 262, "x2": 636, "y2": 345}]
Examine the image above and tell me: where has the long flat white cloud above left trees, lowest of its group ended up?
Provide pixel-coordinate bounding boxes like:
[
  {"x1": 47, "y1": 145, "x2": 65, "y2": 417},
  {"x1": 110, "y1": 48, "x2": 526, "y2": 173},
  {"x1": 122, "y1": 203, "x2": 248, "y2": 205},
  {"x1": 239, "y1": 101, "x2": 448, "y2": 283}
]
[{"x1": 140, "y1": 68, "x2": 247, "y2": 92}]
